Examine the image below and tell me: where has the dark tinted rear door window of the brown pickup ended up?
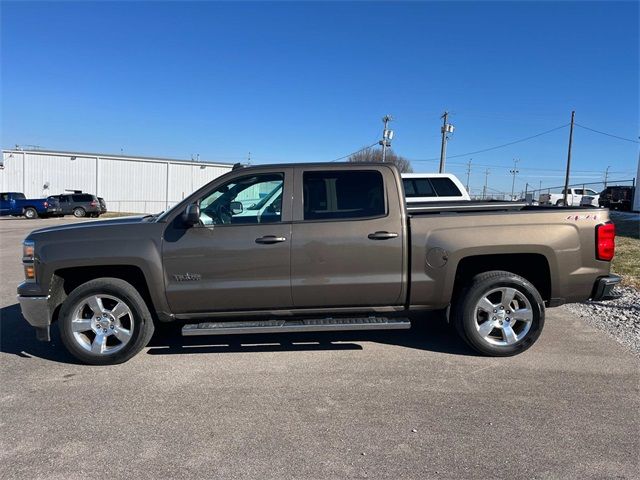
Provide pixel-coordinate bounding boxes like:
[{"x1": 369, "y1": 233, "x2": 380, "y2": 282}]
[{"x1": 302, "y1": 170, "x2": 386, "y2": 220}]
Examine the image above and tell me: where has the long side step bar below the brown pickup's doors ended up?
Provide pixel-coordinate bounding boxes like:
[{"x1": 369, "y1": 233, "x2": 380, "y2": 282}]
[{"x1": 182, "y1": 317, "x2": 411, "y2": 337}]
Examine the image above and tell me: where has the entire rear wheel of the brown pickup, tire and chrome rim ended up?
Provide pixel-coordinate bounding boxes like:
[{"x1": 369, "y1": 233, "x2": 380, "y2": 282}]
[{"x1": 453, "y1": 270, "x2": 545, "y2": 357}]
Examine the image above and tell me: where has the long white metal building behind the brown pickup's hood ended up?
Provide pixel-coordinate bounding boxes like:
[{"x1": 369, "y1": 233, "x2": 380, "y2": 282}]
[{"x1": 0, "y1": 149, "x2": 232, "y2": 213}]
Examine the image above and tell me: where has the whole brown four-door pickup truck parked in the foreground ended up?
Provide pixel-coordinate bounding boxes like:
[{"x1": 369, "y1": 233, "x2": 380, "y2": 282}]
[{"x1": 18, "y1": 163, "x2": 620, "y2": 364}]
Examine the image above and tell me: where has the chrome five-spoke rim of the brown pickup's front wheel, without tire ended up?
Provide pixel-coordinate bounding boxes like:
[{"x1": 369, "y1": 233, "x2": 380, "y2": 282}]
[{"x1": 71, "y1": 294, "x2": 134, "y2": 355}]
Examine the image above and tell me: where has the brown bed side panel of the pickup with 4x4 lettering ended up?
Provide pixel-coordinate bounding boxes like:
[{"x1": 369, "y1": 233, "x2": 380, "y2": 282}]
[{"x1": 410, "y1": 209, "x2": 610, "y2": 308}]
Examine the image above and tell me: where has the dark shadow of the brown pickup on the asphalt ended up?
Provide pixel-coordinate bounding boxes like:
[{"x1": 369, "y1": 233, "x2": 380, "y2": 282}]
[{"x1": 0, "y1": 303, "x2": 476, "y2": 364}]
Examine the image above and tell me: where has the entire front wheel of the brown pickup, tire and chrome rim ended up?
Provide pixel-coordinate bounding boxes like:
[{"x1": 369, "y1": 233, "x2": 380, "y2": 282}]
[{"x1": 59, "y1": 278, "x2": 154, "y2": 365}]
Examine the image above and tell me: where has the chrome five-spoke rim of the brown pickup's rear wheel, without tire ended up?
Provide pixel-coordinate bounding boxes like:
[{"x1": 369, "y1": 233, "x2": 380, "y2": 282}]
[{"x1": 474, "y1": 287, "x2": 533, "y2": 345}]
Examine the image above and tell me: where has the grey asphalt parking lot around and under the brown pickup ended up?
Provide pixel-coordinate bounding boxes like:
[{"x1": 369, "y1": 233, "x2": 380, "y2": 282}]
[{"x1": 0, "y1": 217, "x2": 640, "y2": 479}]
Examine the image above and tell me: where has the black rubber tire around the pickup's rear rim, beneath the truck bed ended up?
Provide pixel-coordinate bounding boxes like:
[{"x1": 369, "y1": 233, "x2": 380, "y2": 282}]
[{"x1": 452, "y1": 270, "x2": 545, "y2": 357}]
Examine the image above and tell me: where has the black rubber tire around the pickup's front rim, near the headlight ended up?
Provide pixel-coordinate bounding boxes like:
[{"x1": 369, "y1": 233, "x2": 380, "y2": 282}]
[{"x1": 58, "y1": 277, "x2": 154, "y2": 365}]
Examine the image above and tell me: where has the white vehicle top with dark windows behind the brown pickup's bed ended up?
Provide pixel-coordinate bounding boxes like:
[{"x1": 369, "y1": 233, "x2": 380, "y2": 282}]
[{"x1": 402, "y1": 173, "x2": 471, "y2": 203}]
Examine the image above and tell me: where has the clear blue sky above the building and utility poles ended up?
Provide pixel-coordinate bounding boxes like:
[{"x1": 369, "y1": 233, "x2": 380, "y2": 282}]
[{"x1": 2, "y1": 2, "x2": 639, "y2": 193}]
